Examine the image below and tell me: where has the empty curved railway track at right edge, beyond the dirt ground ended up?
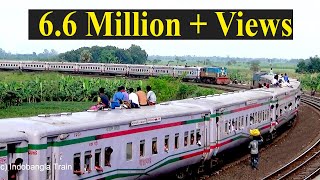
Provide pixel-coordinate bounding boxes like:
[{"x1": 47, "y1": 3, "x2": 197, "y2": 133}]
[{"x1": 263, "y1": 95, "x2": 320, "y2": 180}]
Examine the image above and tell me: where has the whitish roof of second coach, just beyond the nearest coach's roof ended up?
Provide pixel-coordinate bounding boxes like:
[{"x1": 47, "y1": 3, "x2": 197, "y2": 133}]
[{"x1": 172, "y1": 90, "x2": 272, "y2": 110}]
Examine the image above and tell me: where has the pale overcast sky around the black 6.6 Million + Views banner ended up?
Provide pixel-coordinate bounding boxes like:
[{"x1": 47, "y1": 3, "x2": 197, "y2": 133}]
[{"x1": 0, "y1": 0, "x2": 320, "y2": 59}]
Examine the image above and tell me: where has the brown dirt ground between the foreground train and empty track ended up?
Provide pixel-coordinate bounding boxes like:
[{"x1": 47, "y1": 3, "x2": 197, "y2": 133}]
[{"x1": 207, "y1": 104, "x2": 320, "y2": 180}]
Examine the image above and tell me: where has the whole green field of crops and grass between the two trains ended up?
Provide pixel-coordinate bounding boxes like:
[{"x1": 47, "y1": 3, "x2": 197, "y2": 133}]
[{"x1": 0, "y1": 71, "x2": 221, "y2": 118}]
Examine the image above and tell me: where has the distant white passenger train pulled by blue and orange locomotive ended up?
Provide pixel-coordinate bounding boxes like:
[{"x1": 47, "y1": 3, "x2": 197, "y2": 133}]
[{"x1": 0, "y1": 61, "x2": 230, "y2": 84}]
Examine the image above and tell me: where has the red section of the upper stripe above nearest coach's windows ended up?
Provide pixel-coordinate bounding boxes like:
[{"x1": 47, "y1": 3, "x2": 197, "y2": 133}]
[{"x1": 97, "y1": 122, "x2": 183, "y2": 140}]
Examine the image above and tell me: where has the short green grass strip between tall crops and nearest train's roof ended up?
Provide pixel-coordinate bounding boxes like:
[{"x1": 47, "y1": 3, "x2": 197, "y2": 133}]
[{"x1": 0, "y1": 101, "x2": 94, "y2": 119}]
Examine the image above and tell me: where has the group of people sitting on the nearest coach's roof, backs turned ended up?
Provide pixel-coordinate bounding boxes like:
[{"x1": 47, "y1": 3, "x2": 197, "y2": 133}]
[{"x1": 90, "y1": 86, "x2": 157, "y2": 110}]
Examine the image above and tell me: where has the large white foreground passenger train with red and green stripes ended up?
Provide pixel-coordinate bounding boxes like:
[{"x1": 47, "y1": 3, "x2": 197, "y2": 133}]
[{"x1": 0, "y1": 74, "x2": 301, "y2": 180}]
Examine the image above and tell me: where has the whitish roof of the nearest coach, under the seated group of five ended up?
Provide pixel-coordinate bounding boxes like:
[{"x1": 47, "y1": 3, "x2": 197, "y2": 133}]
[{"x1": 0, "y1": 100, "x2": 209, "y2": 134}]
